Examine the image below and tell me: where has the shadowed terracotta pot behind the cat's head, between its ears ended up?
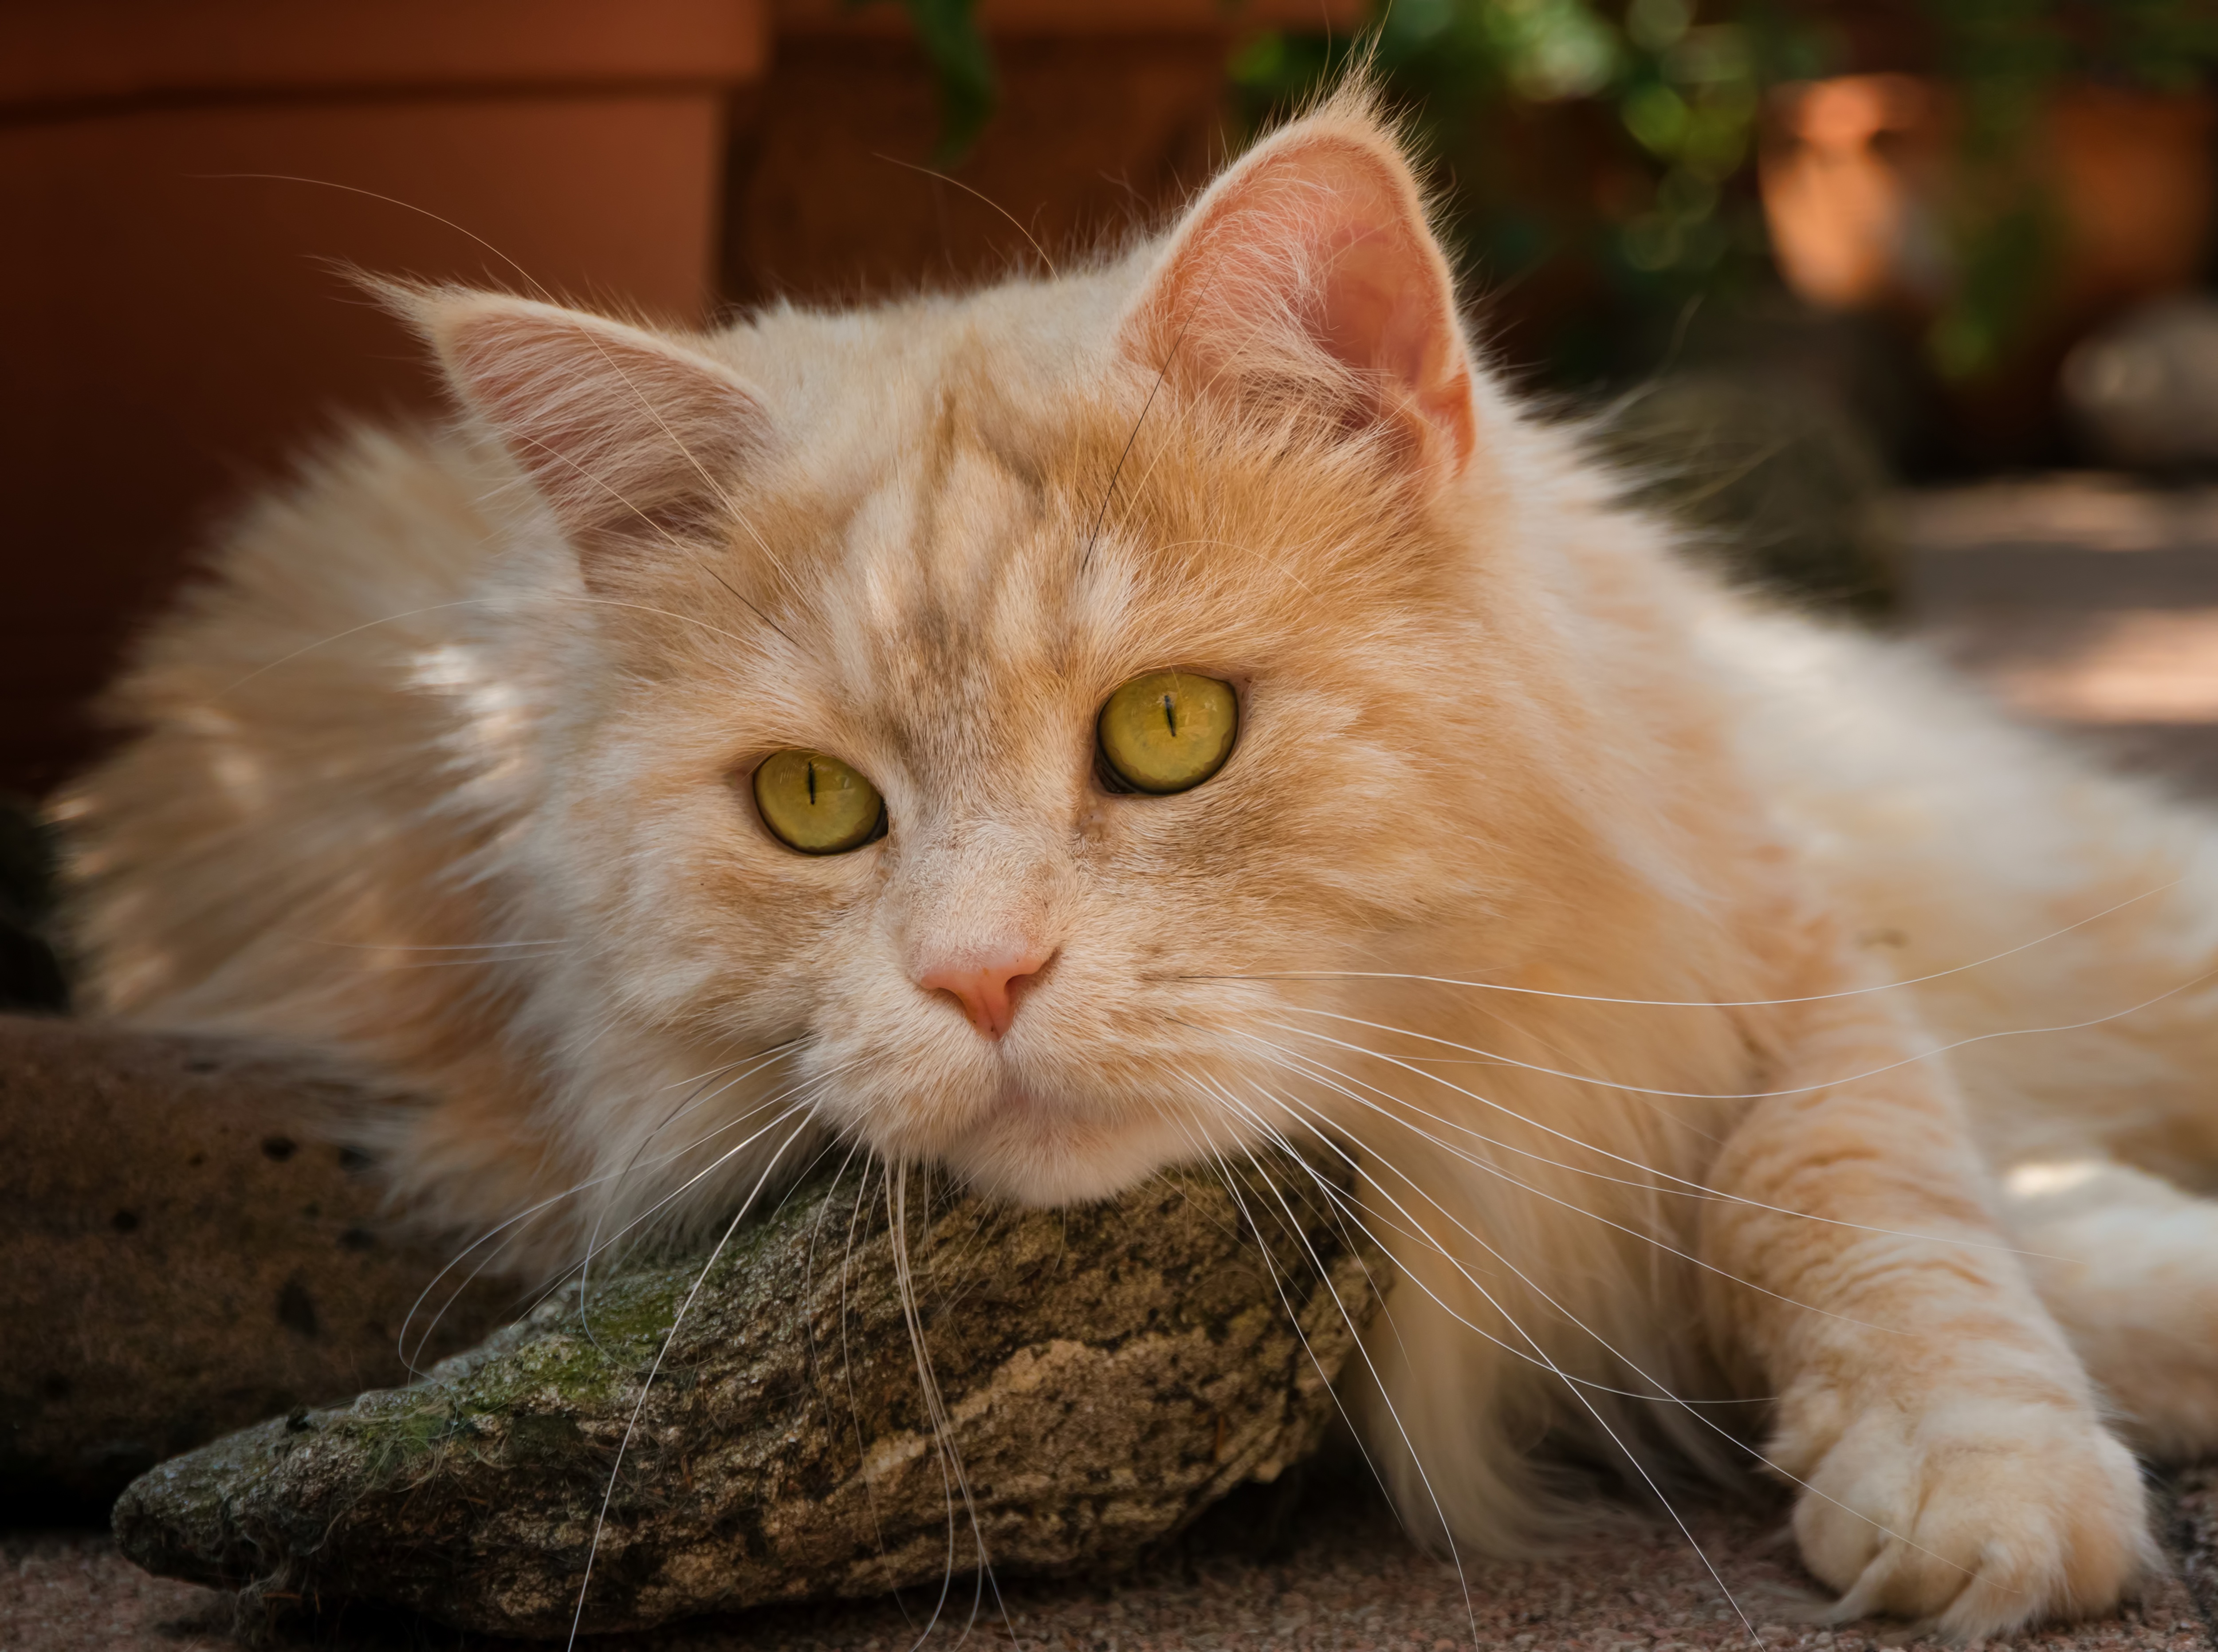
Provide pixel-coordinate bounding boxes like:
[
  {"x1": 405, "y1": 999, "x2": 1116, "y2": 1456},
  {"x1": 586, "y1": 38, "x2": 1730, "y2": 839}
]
[{"x1": 725, "y1": 0, "x2": 1369, "y2": 302}]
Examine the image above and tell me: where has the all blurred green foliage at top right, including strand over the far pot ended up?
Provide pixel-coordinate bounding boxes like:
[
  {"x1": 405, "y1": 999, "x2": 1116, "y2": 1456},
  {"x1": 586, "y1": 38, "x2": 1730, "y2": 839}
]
[{"x1": 1231, "y1": 0, "x2": 2218, "y2": 379}]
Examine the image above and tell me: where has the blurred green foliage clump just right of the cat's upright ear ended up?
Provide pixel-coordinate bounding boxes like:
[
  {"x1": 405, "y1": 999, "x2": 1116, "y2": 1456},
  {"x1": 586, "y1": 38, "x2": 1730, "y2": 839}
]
[{"x1": 1231, "y1": 0, "x2": 1823, "y2": 379}]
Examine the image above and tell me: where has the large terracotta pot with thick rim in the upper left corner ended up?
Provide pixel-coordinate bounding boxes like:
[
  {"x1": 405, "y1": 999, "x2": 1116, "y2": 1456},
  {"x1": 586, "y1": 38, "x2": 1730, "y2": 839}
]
[{"x1": 0, "y1": 0, "x2": 767, "y2": 790}]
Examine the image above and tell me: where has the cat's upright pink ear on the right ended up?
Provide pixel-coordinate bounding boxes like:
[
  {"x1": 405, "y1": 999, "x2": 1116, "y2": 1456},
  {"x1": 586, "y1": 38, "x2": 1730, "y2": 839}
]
[{"x1": 1120, "y1": 93, "x2": 1477, "y2": 477}]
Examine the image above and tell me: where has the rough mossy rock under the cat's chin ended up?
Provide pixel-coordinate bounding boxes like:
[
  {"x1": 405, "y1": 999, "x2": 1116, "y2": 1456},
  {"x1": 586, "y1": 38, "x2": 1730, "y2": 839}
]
[{"x1": 115, "y1": 1164, "x2": 1386, "y2": 1636}]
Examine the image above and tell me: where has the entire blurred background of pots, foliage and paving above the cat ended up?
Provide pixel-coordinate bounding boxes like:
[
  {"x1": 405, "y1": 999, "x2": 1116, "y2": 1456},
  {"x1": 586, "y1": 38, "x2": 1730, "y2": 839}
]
[{"x1": 13, "y1": 0, "x2": 2218, "y2": 825}]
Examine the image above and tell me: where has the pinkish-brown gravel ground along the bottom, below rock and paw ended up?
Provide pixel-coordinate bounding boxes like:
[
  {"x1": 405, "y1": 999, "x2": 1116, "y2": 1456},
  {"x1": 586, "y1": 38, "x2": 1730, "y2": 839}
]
[{"x1": 13, "y1": 1488, "x2": 2214, "y2": 1652}]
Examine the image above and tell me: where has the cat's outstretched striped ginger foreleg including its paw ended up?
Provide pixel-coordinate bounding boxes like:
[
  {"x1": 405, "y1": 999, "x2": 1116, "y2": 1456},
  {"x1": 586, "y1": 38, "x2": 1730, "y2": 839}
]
[{"x1": 1703, "y1": 936, "x2": 2154, "y2": 1636}]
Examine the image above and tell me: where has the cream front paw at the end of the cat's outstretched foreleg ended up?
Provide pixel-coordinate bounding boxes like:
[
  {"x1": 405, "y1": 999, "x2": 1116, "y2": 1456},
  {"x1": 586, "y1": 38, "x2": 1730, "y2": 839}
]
[{"x1": 1794, "y1": 1399, "x2": 2158, "y2": 1641}]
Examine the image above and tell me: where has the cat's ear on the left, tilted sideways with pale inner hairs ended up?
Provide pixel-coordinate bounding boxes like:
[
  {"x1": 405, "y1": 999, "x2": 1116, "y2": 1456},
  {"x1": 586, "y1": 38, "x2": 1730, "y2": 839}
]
[{"x1": 397, "y1": 288, "x2": 770, "y2": 588}]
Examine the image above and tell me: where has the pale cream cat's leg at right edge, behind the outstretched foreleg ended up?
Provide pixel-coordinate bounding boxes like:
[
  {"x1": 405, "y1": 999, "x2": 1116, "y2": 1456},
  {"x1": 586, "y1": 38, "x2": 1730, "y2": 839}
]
[{"x1": 2003, "y1": 1157, "x2": 2218, "y2": 1459}]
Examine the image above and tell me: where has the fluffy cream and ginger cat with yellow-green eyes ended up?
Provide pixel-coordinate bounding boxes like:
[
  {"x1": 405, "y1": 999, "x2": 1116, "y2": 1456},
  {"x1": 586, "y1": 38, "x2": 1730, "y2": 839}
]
[{"x1": 58, "y1": 87, "x2": 2218, "y2": 1636}]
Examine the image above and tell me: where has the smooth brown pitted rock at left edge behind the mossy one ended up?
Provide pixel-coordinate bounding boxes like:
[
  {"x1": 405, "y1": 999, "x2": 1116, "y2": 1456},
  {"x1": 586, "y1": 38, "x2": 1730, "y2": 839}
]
[{"x1": 0, "y1": 1015, "x2": 517, "y2": 1523}]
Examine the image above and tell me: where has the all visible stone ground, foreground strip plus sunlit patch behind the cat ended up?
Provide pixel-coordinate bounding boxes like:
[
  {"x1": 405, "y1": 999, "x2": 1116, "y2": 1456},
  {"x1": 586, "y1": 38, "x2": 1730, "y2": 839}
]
[{"x1": 13, "y1": 477, "x2": 2218, "y2": 1652}]
